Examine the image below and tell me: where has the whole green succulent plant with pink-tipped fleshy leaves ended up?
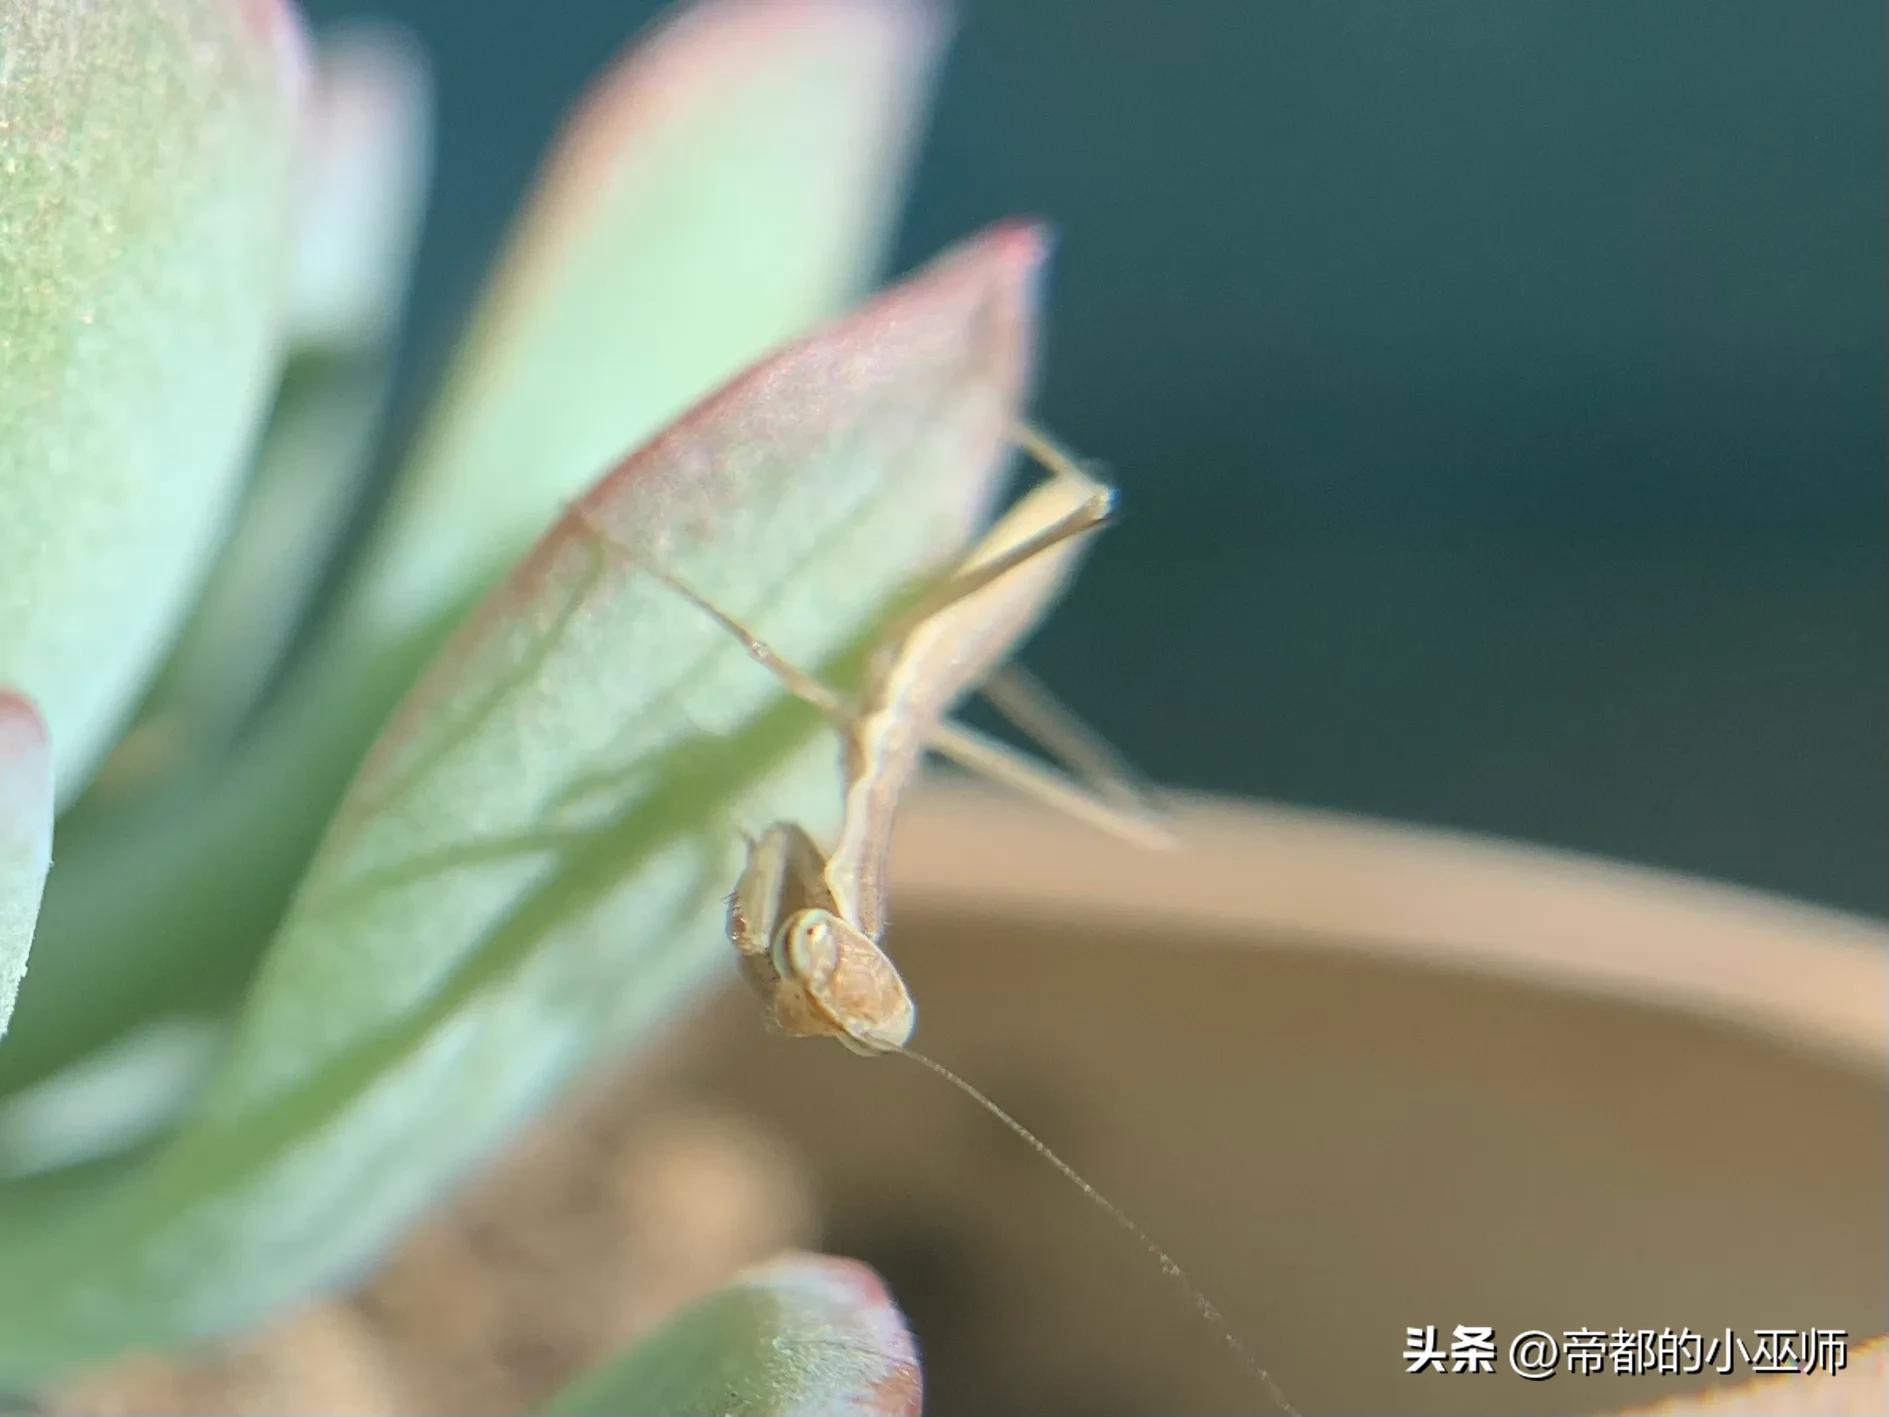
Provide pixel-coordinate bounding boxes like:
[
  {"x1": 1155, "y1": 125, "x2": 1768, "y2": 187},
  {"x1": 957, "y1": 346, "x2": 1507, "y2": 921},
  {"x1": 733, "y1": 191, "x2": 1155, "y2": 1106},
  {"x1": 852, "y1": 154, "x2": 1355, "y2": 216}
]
[{"x1": 0, "y1": 0, "x2": 1045, "y2": 1411}]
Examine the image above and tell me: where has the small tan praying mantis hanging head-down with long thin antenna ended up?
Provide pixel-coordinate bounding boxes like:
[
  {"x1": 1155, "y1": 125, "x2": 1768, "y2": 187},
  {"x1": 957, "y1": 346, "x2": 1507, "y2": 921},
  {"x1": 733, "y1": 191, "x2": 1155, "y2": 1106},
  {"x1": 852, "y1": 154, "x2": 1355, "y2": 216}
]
[{"x1": 630, "y1": 425, "x2": 1296, "y2": 1413}]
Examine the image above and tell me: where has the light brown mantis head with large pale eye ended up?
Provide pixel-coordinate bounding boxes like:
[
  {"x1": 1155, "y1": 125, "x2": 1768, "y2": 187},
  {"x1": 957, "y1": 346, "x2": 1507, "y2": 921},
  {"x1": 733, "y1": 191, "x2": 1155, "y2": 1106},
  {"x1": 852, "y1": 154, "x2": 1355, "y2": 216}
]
[{"x1": 773, "y1": 907, "x2": 918, "y2": 1054}]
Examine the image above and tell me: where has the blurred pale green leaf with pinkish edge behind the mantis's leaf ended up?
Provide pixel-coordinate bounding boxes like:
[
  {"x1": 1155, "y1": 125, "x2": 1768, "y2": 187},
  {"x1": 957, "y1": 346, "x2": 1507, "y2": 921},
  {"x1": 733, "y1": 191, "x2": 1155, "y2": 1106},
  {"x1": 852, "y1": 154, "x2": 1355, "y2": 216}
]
[{"x1": 0, "y1": 0, "x2": 937, "y2": 1088}]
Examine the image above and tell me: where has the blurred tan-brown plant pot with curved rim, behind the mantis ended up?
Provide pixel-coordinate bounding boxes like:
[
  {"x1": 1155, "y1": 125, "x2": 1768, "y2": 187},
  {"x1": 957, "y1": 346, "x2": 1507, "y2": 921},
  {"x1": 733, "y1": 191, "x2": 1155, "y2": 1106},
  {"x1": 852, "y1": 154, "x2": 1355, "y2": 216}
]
[{"x1": 671, "y1": 788, "x2": 1889, "y2": 1413}]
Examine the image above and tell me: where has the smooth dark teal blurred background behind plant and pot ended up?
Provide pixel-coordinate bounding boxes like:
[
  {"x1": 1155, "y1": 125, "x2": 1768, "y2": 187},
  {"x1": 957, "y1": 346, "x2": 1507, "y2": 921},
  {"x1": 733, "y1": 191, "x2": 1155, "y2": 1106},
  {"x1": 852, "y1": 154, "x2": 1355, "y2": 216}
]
[{"x1": 308, "y1": 0, "x2": 1889, "y2": 911}]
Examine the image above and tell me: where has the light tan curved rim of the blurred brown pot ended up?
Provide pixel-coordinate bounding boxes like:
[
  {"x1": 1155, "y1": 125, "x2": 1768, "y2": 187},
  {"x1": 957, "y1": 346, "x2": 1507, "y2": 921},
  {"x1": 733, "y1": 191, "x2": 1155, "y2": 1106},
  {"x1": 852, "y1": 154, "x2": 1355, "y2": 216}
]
[{"x1": 893, "y1": 780, "x2": 1889, "y2": 1075}]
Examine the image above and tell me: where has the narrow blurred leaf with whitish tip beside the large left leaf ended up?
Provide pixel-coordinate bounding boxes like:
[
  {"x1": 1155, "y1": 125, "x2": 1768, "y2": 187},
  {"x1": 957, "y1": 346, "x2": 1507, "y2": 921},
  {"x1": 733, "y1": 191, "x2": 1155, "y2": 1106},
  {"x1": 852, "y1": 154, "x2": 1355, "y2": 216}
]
[{"x1": 85, "y1": 25, "x2": 431, "y2": 809}]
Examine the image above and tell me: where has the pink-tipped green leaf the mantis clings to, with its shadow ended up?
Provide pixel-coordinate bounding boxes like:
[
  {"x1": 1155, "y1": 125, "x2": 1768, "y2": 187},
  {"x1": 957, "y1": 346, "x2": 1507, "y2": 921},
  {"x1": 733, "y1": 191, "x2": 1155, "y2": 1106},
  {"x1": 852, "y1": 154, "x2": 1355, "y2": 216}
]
[{"x1": 0, "y1": 227, "x2": 1043, "y2": 1381}]
